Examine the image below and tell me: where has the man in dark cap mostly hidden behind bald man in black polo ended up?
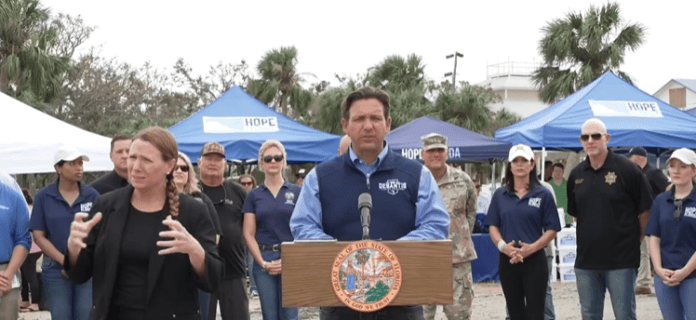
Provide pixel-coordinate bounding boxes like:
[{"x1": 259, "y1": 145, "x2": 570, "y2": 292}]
[{"x1": 628, "y1": 147, "x2": 669, "y2": 294}]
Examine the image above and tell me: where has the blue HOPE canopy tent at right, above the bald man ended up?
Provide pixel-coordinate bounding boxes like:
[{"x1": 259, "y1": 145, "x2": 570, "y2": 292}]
[{"x1": 495, "y1": 72, "x2": 696, "y2": 154}]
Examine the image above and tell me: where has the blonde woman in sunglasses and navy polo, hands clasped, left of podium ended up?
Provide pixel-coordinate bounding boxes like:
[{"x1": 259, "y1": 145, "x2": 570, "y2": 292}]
[{"x1": 242, "y1": 140, "x2": 300, "y2": 320}]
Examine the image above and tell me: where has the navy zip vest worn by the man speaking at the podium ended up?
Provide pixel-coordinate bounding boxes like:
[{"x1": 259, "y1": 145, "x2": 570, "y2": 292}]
[{"x1": 315, "y1": 151, "x2": 423, "y2": 241}]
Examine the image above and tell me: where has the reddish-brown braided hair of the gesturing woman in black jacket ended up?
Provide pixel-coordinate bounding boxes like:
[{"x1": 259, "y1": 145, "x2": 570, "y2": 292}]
[{"x1": 133, "y1": 127, "x2": 179, "y2": 218}]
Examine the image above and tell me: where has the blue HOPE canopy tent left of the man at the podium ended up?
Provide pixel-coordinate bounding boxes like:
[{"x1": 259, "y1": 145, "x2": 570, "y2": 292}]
[{"x1": 169, "y1": 86, "x2": 341, "y2": 163}]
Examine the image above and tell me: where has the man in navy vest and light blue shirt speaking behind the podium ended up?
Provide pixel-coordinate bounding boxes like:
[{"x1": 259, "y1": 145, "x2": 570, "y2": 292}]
[{"x1": 290, "y1": 87, "x2": 450, "y2": 320}]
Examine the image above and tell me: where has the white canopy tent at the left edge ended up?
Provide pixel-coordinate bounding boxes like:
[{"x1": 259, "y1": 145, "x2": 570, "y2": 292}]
[{"x1": 0, "y1": 93, "x2": 114, "y2": 174}]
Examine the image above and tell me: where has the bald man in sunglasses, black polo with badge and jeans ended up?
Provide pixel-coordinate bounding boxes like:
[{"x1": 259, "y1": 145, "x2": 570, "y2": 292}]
[{"x1": 567, "y1": 119, "x2": 652, "y2": 320}]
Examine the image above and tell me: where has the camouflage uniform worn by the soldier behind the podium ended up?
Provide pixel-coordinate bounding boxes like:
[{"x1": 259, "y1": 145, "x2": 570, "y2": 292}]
[{"x1": 423, "y1": 165, "x2": 477, "y2": 320}]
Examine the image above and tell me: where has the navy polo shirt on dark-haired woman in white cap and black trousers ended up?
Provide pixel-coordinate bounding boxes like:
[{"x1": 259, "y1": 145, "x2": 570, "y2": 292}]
[{"x1": 485, "y1": 185, "x2": 561, "y2": 244}]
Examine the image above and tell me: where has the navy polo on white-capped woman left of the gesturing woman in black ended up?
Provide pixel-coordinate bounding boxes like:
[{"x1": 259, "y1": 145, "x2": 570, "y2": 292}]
[{"x1": 29, "y1": 181, "x2": 99, "y2": 253}]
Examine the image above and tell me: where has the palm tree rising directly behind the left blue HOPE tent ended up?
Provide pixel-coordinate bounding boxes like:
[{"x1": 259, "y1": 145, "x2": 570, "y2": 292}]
[{"x1": 247, "y1": 47, "x2": 313, "y2": 115}]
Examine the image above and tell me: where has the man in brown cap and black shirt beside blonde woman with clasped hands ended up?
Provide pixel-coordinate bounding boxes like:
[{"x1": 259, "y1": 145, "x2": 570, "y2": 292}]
[{"x1": 198, "y1": 142, "x2": 249, "y2": 320}]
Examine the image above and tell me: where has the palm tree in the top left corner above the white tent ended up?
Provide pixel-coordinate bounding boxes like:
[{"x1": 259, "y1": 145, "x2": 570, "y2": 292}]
[{"x1": 0, "y1": 0, "x2": 69, "y2": 104}]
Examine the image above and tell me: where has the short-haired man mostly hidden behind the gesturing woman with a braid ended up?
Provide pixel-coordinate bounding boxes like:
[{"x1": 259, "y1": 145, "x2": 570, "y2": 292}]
[{"x1": 90, "y1": 135, "x2": 132, "y2": 194}]
